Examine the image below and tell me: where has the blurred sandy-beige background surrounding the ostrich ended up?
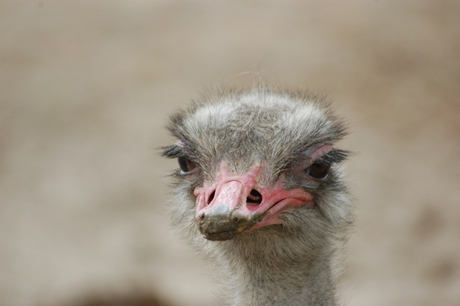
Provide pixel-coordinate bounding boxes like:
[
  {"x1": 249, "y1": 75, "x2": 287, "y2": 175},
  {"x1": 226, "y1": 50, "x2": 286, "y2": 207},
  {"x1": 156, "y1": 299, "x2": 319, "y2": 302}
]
[{"x1": 0, "y1": 0, "x2": 460, "y2": 306}]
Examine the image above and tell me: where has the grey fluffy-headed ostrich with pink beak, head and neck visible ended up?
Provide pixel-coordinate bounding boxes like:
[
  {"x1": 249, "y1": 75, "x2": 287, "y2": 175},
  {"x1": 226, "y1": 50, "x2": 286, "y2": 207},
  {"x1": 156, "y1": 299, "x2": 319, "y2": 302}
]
[{"x1": 162, "y1": 86, "x2": 353, "y2": 306}]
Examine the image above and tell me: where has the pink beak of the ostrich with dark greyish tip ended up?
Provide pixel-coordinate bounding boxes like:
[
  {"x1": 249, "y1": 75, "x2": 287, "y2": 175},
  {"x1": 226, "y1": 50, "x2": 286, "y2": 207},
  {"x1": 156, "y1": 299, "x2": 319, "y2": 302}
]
[{"x1": 194, "y1": 163, "x2": 313, "y2": 241}]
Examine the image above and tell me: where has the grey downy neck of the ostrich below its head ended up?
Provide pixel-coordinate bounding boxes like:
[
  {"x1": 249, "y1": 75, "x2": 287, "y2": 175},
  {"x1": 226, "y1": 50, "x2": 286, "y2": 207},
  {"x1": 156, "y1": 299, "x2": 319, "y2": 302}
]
[{"x1": 219, "y1": 240, "x2": 336, "y2": 306}]
